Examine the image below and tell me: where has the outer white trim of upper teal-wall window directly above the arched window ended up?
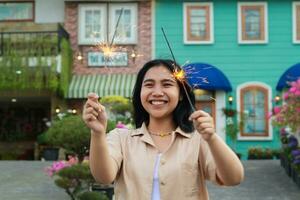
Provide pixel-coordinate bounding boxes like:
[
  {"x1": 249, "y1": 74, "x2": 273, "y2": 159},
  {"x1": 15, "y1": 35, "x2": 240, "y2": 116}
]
[{"x1": 237, "y1": 2, "x2": 269, "y2": 44}]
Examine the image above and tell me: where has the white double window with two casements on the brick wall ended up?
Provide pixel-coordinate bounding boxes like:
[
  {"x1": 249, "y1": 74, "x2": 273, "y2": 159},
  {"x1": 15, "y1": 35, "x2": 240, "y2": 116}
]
[{"x1": 78, "y1": 3, "x2": 137, "y2": 44}]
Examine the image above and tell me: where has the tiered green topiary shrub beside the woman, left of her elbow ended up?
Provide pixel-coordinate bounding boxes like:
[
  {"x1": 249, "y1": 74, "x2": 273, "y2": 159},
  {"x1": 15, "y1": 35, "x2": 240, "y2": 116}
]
[{"x1": 46, "y1": 115, "x2": 113, "y2": 199}]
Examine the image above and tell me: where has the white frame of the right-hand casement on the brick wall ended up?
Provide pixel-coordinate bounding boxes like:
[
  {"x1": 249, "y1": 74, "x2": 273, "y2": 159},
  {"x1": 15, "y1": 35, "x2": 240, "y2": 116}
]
[{"x1": 109, "y1": 3, "x2": 138, "y2": 44}]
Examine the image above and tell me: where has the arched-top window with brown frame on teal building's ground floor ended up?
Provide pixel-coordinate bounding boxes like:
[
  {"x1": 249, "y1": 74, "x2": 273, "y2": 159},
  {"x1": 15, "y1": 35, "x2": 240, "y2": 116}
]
[{"x1": 238, "y1": 84, "x2": 271, "y2": 139}]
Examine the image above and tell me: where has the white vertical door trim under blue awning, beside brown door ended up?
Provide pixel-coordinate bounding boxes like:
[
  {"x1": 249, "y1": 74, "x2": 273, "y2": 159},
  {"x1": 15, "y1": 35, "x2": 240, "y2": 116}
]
[{"x1": 215, "y1": 91, "x2": 226, "y2": 142}]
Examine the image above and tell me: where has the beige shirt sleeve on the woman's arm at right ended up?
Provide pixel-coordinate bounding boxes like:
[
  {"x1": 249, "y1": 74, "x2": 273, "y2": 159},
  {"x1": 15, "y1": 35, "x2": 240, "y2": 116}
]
[{"x1": 199, "y1": 138, "x2": 223, "y2": 185}]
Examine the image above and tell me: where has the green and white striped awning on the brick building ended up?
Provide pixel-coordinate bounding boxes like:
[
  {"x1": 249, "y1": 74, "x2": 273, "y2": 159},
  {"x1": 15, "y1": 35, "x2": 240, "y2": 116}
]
[{"x1": 67, "y1": 74, "x2": 136, "y2": 99}]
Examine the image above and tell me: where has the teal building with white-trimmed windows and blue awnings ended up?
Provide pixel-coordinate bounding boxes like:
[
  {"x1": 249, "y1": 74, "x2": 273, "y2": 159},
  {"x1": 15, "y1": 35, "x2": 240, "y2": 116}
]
[{"x1": 153, "y1": 0, "x2": 300, "y2": 159}]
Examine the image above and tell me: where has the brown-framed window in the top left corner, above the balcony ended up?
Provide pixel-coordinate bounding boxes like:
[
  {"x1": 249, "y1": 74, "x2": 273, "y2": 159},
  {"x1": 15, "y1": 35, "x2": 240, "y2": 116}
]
[{"x1": 0, "y1": 2, "x2": 34, "y2": 21}]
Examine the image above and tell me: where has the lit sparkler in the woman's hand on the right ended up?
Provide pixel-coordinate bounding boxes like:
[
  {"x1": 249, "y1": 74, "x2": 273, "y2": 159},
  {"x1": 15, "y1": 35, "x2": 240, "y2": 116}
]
[{"x1": 161, "y1": 27, "x2": 196, "y2": 112}]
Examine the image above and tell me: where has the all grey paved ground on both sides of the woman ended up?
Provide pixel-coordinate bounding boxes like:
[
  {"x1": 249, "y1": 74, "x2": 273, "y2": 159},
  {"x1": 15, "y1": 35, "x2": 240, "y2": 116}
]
[{"x1": 0, "y1": 160, "x2": 300, "y2": 200}]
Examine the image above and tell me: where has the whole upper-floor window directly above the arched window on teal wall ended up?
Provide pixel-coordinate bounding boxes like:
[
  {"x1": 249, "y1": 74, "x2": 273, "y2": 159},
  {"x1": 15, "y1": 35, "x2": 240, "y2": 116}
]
[{"x1": 238, "y1": 2, "x2": 268, "y2": 44}]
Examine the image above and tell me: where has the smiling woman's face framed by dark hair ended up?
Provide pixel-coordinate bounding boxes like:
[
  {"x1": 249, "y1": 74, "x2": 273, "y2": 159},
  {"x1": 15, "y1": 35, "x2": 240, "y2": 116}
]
[{"x1": 141, "y1": 65, "x2": 180, "y2": 118}]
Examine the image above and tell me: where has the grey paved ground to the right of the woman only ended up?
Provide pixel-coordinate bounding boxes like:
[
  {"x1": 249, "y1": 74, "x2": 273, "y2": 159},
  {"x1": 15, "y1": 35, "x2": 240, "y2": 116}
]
[{"x1": 209, "y1": 160, "x2": 300, "y2": 200}]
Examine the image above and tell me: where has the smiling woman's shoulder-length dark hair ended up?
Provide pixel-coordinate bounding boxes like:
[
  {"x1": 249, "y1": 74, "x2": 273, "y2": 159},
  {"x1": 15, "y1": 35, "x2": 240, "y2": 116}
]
[{"x1": 132, "y1": 59, "x2": 195, "y2": 133}]
